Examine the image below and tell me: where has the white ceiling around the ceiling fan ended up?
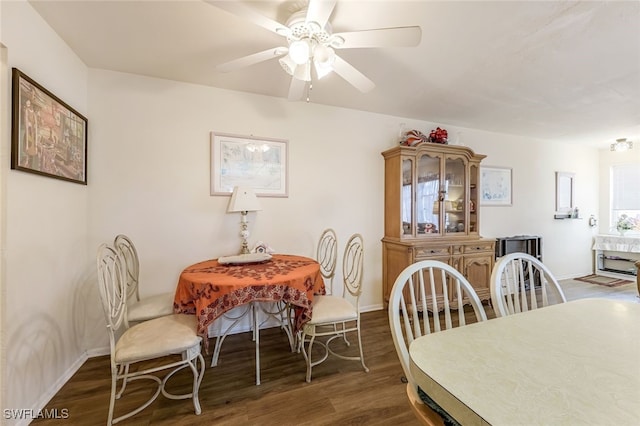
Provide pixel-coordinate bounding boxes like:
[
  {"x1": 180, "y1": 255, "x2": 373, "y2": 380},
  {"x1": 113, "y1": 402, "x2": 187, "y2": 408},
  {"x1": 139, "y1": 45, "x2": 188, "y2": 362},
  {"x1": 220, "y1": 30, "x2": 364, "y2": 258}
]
[{"x1": 30, "y1": 0, "x2": 640, "y2": 148}]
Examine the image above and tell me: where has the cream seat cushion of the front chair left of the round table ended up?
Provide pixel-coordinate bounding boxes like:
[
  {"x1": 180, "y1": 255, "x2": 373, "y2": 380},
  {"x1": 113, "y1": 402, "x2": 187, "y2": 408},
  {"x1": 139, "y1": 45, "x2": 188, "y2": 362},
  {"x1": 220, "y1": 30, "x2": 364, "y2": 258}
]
[{"x1": 114, "y1": 314, "x2": 202, "y2": 364}]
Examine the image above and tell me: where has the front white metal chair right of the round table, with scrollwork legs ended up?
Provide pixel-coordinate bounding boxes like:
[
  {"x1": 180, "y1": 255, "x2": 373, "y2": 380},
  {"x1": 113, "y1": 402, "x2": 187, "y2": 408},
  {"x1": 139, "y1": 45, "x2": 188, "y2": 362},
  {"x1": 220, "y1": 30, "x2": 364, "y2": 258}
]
[{"x1": 300, "y1": 234, "x2": 369, "y2": 382}]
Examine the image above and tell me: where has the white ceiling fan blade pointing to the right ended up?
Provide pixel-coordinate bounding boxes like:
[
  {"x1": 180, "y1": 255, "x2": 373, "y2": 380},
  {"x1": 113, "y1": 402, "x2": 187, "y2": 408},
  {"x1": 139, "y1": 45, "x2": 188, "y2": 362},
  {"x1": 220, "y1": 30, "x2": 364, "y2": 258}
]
[{"x1": 332, "y1": 27, "x2": 422, "y2": 49}]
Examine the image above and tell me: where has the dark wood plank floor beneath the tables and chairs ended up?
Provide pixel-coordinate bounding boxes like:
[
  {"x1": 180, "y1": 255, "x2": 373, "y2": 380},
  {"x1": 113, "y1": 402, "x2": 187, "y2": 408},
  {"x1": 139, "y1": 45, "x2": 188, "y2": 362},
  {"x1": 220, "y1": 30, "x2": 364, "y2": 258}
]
[{"x1": 33, "y1": 306, "x2": 493, "y2": 426}]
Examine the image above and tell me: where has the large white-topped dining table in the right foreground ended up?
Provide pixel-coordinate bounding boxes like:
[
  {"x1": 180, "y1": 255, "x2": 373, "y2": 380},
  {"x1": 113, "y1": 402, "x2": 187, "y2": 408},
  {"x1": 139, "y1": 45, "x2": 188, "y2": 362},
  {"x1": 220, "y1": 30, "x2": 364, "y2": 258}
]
[{"x1": 409, "y1": 299, "x2": 640, "y2": 426}]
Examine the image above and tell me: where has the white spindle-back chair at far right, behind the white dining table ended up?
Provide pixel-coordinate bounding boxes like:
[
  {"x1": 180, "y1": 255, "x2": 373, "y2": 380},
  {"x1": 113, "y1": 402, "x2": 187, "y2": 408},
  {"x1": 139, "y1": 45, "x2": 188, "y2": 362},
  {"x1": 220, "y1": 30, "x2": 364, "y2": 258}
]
[{"x1": 491, "y1": 253, "x2": 567, "y2": 317}]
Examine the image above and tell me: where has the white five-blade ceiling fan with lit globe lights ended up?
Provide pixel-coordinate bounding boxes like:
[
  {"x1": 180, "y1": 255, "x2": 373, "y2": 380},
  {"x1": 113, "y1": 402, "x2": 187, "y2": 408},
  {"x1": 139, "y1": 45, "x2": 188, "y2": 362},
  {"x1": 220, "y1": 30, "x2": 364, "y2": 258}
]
[{"x1": 206, "y1": 0, "x2": 422, "y2": 100}]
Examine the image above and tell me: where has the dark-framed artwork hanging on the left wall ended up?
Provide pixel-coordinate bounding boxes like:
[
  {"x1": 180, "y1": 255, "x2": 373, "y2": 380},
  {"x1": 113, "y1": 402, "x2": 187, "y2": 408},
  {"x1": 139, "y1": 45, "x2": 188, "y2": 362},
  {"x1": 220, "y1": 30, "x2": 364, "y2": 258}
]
[{"x1": 11, "y1": 68, "x2": 88, "y2": 185}]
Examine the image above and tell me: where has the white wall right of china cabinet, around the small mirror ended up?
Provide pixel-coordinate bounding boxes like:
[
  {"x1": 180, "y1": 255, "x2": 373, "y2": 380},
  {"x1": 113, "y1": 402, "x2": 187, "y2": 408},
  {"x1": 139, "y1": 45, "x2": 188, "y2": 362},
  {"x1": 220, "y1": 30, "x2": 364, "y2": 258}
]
[{"x1": 469, "y1": 131, "x2": 599, "y2": 279}]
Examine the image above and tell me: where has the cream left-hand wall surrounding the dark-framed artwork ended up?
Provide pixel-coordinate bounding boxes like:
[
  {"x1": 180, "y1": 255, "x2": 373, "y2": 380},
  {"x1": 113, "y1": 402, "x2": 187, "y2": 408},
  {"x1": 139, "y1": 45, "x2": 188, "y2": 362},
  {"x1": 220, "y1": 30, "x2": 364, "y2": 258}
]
[{"x1": 0, "y1": 1, "x2": 90, "y2": 424}]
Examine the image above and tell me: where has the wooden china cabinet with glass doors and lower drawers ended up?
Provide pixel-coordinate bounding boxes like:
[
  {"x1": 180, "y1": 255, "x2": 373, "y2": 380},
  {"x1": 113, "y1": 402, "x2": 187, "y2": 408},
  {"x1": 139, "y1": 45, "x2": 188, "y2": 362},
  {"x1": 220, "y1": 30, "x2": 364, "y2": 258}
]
[{"x1": 382, "y1": 143, "x2": 495, "y2": 306}]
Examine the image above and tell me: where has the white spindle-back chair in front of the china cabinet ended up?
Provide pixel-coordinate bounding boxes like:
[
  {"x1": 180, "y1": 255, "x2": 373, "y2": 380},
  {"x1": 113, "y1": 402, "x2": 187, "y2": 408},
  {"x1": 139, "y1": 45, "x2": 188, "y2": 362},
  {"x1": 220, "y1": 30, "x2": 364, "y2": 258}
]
[{"x1": 389, "y1": 260, "x2": 487, "y2": 425}]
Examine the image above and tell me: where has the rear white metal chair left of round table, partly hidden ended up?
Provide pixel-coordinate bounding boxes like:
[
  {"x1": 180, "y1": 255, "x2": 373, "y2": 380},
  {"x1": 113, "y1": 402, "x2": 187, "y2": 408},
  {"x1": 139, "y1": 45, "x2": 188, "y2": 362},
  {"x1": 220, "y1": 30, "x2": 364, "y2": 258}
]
[{"x1": 113, "y1": 234, "x2": 174, "y2": 323}]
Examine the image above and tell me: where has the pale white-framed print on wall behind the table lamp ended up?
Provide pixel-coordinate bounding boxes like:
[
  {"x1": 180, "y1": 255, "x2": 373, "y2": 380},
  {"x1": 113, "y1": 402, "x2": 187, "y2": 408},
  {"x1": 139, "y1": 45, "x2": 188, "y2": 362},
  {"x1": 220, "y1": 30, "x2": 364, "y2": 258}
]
[{"x1": 211, "y1": 132, "x2": 288, "y2": 197}]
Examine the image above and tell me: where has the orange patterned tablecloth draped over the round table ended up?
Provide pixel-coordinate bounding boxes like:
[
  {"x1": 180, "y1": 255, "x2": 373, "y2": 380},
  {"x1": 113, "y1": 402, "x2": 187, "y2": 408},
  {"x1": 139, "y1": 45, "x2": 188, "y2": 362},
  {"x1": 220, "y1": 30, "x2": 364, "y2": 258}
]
[{"x1": 173, "y1": 254, "x2": 325, "y2": 342}]
